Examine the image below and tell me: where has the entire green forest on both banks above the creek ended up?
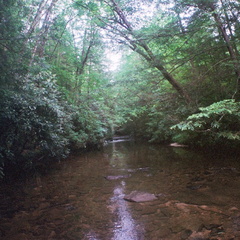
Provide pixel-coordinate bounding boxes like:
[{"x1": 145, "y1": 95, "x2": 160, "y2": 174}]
[{"x1": 0, "y1": 0, "x2": 240, "y2": 177}]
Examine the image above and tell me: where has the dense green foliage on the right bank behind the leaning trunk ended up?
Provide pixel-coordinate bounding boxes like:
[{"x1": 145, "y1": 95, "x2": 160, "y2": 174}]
[{"x1": 94, "y1": 1, "x2": 240, "y2": 146}]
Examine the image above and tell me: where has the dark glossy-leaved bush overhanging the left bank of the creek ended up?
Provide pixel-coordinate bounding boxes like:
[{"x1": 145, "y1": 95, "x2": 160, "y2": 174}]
[{"x1": 0, "y1": 72, "x2": 71, "y2": 175}]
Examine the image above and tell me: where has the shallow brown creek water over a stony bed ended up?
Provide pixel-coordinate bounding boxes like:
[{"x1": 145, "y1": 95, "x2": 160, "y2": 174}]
[{"x1": 0, "y1": 141, "x2": 240, "y2": 240}]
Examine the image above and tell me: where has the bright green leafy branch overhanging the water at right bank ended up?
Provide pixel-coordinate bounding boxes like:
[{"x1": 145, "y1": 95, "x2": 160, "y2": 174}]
[{"x1": 171, "y1": 99, "x2": 240, "y2": 146}]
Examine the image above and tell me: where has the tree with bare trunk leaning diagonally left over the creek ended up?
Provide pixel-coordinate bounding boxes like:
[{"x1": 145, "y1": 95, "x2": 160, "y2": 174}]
[{"x1": 76, "y1": 0, "x2": 191, "y2": 103}]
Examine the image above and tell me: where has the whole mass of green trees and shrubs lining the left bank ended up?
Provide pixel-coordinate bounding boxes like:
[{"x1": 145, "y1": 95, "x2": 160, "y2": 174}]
[{"x1": 0, "y1": 0, "x2": 111, "y2": 175}]
